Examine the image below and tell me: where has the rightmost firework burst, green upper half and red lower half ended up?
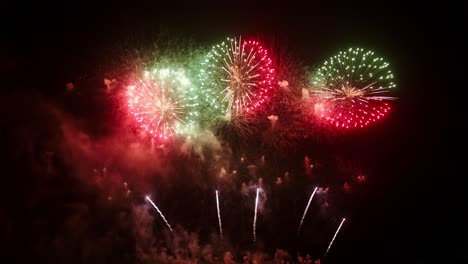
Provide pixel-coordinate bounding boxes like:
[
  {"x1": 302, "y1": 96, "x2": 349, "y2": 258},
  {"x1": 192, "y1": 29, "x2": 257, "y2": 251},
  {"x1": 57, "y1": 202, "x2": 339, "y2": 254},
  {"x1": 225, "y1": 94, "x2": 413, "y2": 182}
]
[{"x1": 311, "y1": 48, "x2": 396, "y2": 129}]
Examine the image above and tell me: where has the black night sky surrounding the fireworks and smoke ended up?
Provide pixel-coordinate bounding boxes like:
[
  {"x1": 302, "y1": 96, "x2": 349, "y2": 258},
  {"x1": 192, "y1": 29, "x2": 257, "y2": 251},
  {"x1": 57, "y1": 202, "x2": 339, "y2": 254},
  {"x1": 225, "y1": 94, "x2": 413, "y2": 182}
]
[{"x1": 0, "y1": 1, "x2": 460, "y2": 263}]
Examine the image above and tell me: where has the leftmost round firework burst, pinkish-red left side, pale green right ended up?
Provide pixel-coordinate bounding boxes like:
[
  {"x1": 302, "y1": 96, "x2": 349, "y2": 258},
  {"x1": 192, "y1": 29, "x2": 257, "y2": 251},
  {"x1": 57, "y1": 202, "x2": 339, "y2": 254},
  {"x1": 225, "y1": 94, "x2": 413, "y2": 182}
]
[{"x1": 126, "y1": 69, "x2": 198, "y2": 140}]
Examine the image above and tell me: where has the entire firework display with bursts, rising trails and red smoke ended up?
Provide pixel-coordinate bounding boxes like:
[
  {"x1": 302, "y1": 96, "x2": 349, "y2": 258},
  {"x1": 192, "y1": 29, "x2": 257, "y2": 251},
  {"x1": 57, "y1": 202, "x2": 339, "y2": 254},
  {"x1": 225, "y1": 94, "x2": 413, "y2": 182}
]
[{"x1": 32, "y1": 35, "x2": 396, "y2": 263}]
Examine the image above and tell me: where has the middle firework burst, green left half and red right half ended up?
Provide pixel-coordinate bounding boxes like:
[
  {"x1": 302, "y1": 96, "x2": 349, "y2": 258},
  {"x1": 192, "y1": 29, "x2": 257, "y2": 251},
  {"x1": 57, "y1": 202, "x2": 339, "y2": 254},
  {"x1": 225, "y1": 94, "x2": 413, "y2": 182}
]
[{"x1": 200, "y1": 38, "x2": 275, "y2": 117}]
